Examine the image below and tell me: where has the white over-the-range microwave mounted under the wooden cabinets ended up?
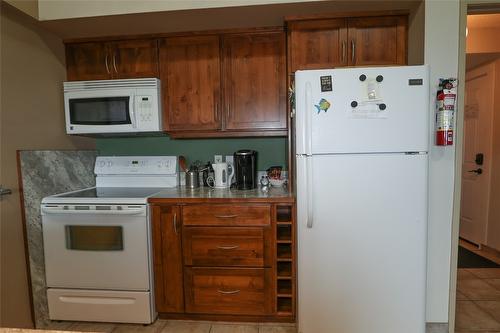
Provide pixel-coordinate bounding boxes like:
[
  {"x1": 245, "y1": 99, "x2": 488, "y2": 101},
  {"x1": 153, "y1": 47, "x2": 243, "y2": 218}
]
[{"x1": 64, "y1": 78, "x2": 162, "y2": 134}]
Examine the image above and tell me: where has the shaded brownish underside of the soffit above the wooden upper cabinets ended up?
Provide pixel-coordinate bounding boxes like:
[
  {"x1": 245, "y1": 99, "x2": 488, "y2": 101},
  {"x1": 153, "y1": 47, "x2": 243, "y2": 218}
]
[{"x1": 31, "y1": 0, "x2": 421, "y2": 39}]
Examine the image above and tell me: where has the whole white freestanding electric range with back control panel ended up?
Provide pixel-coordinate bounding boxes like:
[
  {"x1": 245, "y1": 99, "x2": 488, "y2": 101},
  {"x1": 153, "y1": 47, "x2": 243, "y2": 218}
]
[{"x1": 41, "y1": 156, "x2": 179, "y2": 324}]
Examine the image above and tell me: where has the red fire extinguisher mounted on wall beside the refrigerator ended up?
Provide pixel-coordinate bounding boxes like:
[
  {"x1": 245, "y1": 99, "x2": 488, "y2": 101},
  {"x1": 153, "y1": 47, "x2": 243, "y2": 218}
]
[{"x1": 436, "y1": 78, "x2": 457, "y2": 146}]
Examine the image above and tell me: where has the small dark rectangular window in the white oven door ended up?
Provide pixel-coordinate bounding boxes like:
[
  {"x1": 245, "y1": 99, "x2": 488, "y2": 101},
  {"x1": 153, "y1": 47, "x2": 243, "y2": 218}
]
[{"x1": 66, "y1": 225, "x2": 123, "y2": 251}]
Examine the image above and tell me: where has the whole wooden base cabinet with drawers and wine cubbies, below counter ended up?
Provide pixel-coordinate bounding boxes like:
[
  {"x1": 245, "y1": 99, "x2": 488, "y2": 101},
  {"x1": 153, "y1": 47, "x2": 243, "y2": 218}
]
[{"x1": 152, "y1": 201, "x2": 296, "y2": 322}]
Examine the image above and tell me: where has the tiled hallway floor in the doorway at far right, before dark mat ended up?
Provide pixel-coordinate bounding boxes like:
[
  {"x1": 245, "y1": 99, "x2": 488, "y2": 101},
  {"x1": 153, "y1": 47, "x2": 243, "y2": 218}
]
[{"x1": 455, "y1": 268, "x2": 500, "y2": 333}]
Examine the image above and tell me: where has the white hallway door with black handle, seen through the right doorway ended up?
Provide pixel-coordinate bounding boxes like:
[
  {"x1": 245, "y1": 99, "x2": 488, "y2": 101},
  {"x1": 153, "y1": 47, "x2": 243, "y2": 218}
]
[{"x1": 460, "y1": 64, "x2": 495, "y2": 245}]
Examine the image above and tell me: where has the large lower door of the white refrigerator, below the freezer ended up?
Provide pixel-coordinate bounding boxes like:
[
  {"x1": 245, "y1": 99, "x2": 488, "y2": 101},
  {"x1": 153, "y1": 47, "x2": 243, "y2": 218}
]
[{"x1": 297, "y1": 154, "x2": 427, "y2": 333}]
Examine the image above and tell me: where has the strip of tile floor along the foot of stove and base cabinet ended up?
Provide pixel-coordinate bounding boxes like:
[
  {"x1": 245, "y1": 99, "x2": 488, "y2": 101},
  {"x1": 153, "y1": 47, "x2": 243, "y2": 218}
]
[{"x1": 41, "y1": 319, "x2": 297, "y2": 333}]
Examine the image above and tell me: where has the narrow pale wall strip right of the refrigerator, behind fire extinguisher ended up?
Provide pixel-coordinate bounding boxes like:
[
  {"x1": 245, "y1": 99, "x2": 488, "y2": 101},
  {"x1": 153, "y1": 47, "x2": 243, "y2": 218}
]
[{"x1": 425, "y1": 0, "x2": 460, "y2": 323}]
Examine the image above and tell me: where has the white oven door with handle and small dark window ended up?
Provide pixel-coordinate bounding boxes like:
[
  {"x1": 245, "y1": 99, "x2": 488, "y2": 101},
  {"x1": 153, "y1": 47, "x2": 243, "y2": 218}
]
[{"x1": 42, "y1": 204, "x2": 150, "y2": 290}]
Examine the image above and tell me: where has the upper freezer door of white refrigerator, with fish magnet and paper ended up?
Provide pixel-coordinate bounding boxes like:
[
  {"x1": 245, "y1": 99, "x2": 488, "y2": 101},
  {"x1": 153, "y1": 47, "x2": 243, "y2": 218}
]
[{"x1": 296, "y1": 66, "x2": 430, "y2": 154}]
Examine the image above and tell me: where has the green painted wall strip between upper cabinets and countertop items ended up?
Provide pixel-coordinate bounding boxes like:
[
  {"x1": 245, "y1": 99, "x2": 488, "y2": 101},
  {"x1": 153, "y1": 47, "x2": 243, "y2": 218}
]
[{"x1": 96, "y1": 136, "x2": 287, "y2": 170}]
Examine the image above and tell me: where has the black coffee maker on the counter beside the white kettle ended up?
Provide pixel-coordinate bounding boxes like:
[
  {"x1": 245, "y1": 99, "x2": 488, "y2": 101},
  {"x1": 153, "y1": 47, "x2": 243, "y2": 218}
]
[{"x1": 233, "y1": 149, "x2": 257, "y2": 190}]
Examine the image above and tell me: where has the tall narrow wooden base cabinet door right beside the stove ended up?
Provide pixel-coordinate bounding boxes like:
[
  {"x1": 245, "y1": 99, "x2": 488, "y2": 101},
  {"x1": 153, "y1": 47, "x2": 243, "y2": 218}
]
[{"x1": 152, "y1": 206, "x2": 184, "y2": 312}]
